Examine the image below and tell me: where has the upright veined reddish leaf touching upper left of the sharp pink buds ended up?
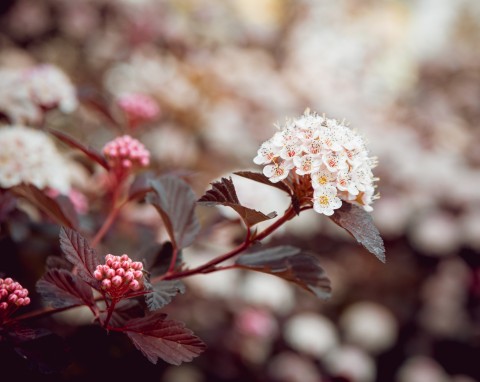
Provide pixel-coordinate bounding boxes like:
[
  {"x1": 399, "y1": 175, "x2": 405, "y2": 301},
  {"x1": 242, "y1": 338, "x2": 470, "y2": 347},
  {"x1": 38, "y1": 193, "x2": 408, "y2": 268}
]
[{"x1": 60, "y1": 227, "x2": 100, "y2": 285}]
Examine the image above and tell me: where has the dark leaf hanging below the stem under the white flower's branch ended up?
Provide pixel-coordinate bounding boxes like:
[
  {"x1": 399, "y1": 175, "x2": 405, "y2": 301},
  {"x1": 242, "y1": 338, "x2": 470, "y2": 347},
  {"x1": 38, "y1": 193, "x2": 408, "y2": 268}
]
[{"x1": 236, "y1": 246, "x2": 331, "y2": 299}]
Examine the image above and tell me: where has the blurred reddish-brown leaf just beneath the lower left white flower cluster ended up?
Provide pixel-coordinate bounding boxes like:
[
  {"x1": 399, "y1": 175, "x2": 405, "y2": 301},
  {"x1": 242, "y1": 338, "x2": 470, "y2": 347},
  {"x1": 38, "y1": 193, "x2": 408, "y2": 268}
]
[{"x1": 10, "y1": 184, "x2": 77, "y2": 228}]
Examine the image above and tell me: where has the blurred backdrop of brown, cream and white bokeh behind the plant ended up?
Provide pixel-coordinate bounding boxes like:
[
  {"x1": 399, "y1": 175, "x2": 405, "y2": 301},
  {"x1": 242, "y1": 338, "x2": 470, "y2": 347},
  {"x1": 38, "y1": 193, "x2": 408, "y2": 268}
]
[{"x1": 0, "y1": 0, "x2": 480, "y2": 382}]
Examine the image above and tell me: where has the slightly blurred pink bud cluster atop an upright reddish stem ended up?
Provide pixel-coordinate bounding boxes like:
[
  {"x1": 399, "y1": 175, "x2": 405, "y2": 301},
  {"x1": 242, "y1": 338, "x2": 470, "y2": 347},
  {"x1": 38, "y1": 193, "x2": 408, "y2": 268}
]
[{"x1": 103, "y1": 135, "x2": 150, "y2": 173}]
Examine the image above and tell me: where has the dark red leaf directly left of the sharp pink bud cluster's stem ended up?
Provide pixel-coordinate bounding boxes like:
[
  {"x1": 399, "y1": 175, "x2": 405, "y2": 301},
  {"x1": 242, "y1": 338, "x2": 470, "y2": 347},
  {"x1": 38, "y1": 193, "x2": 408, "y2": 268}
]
[{"x1": 36, "y1": 269, "x2": 95, "y2": 308}]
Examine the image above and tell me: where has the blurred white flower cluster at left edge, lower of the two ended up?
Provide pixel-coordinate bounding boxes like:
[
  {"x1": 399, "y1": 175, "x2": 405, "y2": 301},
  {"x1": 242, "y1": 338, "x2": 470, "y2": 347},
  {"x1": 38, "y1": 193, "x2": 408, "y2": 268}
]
[{"x1": 0, "y1": 125, "x2": 71, "y2": 194}]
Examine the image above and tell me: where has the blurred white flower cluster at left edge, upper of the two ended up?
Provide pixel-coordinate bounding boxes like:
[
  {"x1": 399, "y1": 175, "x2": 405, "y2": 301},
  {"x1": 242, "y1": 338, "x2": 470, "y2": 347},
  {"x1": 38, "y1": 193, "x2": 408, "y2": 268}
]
[{"x1": 0, "y1": 65, "x2": 78, "y2": 125}]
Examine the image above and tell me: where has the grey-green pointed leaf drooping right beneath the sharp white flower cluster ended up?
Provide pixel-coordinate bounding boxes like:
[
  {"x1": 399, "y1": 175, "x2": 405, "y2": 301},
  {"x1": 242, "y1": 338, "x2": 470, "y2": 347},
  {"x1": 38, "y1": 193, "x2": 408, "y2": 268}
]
[{"x1": 330, "y1": 203, "x2": 386, "y2": 263}]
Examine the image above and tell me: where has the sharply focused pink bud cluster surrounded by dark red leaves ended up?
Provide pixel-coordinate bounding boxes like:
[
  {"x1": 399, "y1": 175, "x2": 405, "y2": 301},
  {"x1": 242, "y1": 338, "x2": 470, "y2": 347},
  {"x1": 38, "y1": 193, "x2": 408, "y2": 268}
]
[{"x1": 93, "y1": 254, "x2": 143, "y2": 298}]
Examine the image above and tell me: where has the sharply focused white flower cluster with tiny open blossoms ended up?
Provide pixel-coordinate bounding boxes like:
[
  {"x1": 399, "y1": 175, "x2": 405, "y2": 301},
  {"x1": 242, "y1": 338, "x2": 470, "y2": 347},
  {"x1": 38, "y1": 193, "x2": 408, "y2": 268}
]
[{"x1": 253, "y1": 110, "x2": 377, "y2": 215}]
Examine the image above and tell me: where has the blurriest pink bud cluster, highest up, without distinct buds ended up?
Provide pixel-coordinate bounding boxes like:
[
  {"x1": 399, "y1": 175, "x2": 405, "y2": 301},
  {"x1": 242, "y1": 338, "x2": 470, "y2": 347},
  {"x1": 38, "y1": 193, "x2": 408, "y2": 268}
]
[{"x1": 117, "y1": 93, "x2": 160, "y2": 128}]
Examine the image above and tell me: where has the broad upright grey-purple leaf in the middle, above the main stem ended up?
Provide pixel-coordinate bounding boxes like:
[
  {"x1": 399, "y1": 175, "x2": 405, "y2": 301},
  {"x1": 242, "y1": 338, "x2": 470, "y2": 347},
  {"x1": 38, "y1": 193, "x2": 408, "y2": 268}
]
[{"x1": 147, "y1": 175, "x2": 200, "y2": 249}]
